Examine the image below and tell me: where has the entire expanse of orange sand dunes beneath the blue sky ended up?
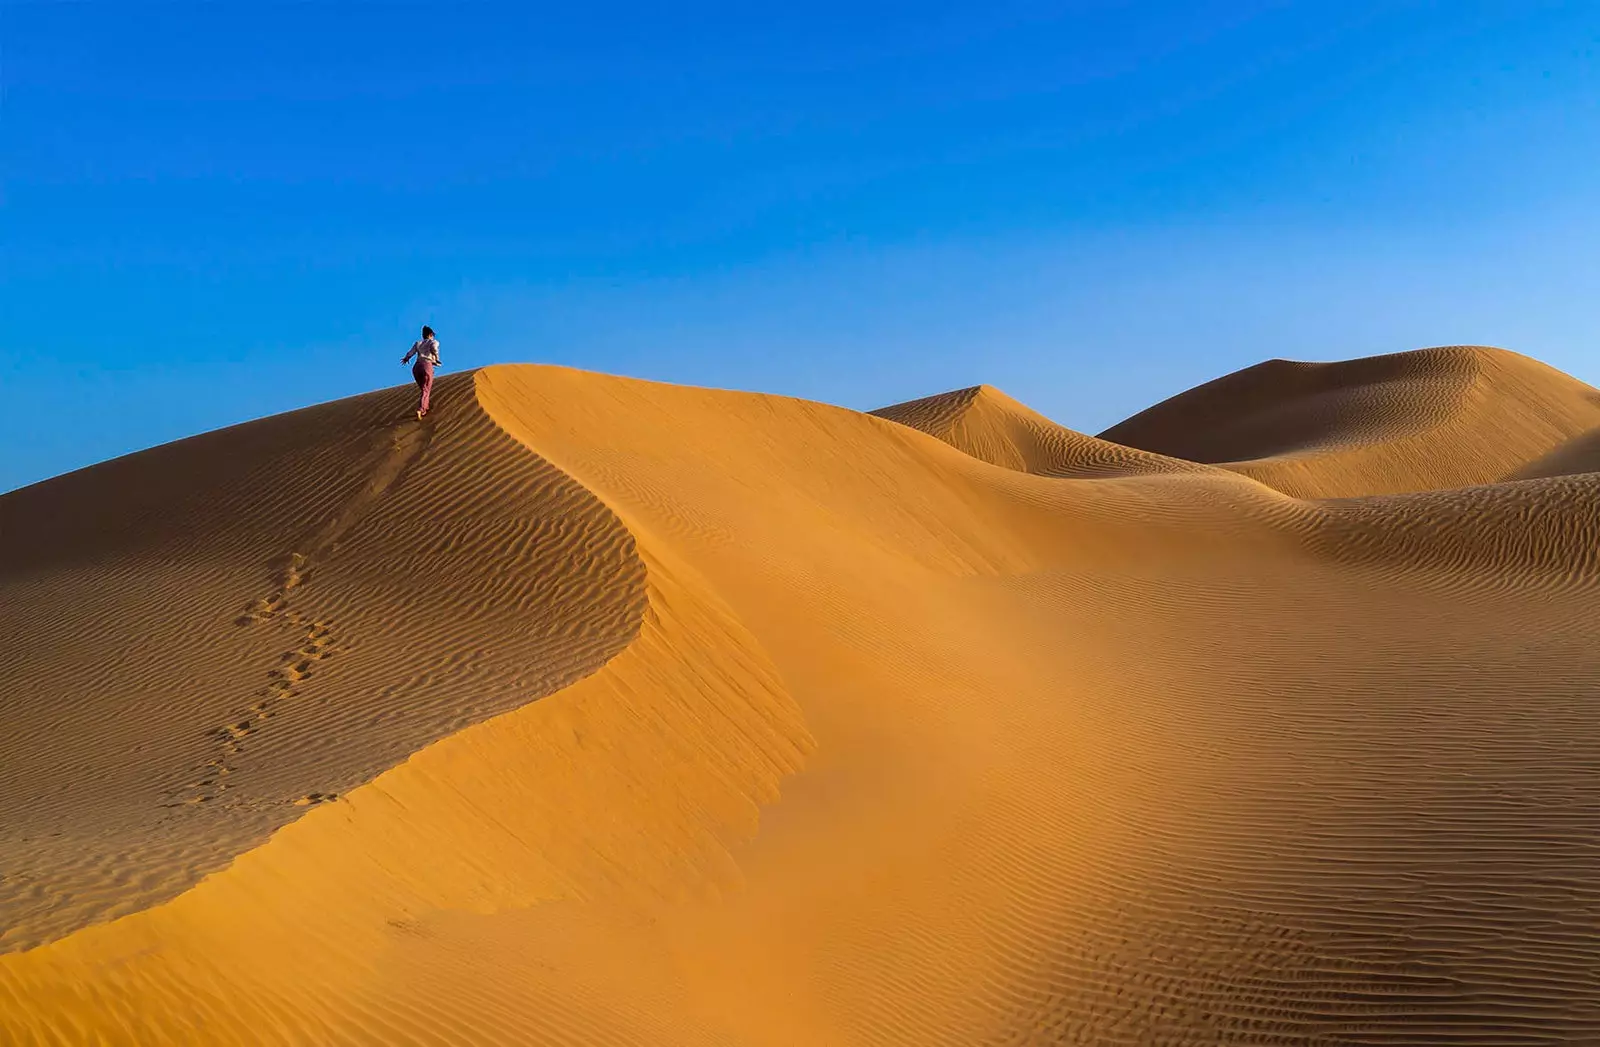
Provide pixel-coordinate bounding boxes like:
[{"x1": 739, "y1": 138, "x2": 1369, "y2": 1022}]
[{"x1": 0, "y1": 351, "x2": 1600, "y2": 1045}]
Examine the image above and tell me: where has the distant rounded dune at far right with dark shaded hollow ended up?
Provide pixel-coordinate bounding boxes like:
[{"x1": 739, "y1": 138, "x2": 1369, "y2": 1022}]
[{"x1": 1101, "y1": 346, "x2": 1600, "y2": 498}]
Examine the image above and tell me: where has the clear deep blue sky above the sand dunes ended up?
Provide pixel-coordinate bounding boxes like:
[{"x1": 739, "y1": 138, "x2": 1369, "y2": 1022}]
[{"x1": 0, "y1": 0, "x2": 1600, "y2": 490}]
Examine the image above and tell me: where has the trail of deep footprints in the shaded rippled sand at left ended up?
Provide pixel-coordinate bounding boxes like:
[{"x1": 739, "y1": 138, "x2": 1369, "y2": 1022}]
[{"x1": 184, "y1": 552, "x2": 341, "y2": 807}]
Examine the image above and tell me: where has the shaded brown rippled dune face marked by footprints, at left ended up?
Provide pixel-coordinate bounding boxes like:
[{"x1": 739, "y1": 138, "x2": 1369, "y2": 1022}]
[{"x1": 0, "y1": 376, "x2": 645, "y2": 951}]
